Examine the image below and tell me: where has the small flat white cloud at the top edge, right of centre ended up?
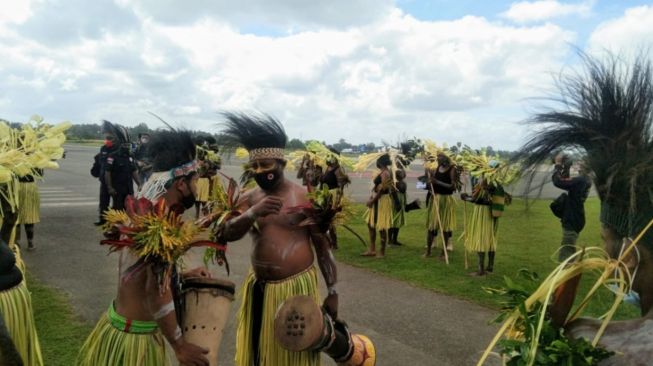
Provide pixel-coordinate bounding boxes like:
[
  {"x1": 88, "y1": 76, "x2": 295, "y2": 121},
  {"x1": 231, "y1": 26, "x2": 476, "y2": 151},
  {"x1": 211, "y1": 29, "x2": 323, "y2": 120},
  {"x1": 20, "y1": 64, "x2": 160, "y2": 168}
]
[{"x1": 501, "y1": 0, "x2": 595, "y2": 23}]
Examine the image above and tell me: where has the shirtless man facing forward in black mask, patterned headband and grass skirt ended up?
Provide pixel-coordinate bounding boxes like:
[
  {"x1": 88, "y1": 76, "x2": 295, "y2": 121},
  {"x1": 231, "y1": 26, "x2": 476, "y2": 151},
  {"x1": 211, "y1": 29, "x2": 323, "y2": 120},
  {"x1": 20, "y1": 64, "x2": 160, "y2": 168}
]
[{"x1": 222, "y1": 113, "x2": 338, "y2": 366}]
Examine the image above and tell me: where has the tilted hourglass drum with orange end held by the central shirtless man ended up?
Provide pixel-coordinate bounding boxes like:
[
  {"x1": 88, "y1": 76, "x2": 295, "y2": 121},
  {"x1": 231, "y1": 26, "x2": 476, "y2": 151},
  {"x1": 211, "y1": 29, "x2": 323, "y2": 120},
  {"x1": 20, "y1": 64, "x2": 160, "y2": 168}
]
[{"x1": 274, "y1": 296, "x2": 376, "y2": 366}]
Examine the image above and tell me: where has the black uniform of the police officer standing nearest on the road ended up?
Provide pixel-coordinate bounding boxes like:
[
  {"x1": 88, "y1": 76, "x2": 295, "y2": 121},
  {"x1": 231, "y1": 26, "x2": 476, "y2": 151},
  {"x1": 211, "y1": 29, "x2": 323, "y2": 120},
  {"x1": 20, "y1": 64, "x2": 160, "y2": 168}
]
[{"x1": 105, "y1": 149, "x2": 136, "y2": 210}]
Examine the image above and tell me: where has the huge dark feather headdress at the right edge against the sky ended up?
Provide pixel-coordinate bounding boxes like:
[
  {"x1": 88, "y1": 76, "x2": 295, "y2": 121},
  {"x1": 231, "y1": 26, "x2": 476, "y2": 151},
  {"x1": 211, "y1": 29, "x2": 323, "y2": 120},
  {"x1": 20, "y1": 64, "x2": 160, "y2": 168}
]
[{"x1": 517, "y1": 53, "x2": 653, "y2": 247}]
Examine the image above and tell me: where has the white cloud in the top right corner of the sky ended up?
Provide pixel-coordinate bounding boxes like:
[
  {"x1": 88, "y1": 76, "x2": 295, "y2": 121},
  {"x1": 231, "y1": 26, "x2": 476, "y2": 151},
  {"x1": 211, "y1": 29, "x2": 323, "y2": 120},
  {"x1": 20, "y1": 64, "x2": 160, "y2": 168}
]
[{"x1": 589, "y1": 6, "x2": 653, "y2": 53}]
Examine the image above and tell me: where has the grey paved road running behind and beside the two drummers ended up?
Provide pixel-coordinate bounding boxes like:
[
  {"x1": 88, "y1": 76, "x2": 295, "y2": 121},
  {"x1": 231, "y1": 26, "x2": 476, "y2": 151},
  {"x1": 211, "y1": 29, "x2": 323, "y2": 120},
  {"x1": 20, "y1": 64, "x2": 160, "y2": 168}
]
[{"x1": 24, "y1": 146, "x2": 516, "y2": 366}]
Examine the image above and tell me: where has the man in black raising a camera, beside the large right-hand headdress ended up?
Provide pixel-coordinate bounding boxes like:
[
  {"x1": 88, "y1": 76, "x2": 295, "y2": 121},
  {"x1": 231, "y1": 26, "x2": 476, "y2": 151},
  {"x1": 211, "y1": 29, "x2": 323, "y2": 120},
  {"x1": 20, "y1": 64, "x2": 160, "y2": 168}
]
[{"x1": 552, "y1": 155, "x2": 592, "y2": 261}]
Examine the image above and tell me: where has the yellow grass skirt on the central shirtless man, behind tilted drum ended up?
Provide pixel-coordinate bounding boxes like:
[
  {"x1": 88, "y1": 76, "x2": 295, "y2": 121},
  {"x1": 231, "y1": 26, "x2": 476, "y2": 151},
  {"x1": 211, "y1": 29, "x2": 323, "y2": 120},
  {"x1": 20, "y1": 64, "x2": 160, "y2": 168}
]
[{"x1": 236, "y1": 267, "x2": 320, "y2": 366}]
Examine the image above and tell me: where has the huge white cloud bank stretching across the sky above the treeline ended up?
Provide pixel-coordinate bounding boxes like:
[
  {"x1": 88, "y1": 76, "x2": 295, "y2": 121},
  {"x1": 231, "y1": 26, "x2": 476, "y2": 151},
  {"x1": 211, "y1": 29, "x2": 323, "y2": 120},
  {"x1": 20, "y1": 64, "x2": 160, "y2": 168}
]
[{"x1": 0, "y1": 1, "x2": 574, "y2": 148}]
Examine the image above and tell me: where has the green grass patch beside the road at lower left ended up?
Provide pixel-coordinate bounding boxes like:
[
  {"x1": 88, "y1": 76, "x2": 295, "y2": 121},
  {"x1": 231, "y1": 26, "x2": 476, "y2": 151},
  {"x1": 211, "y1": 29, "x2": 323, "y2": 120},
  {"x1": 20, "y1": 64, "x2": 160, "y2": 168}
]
[{"x1": 27, "y1": 274, "x2": 93, "y2": 366}]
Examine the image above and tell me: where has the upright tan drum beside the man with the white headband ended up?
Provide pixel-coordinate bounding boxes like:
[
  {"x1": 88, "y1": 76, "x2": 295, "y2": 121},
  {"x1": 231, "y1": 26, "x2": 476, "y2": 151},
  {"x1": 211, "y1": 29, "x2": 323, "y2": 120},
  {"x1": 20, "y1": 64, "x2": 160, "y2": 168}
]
[{"x1": 179, "y1": 278, "x2": 235, "y2": 366}]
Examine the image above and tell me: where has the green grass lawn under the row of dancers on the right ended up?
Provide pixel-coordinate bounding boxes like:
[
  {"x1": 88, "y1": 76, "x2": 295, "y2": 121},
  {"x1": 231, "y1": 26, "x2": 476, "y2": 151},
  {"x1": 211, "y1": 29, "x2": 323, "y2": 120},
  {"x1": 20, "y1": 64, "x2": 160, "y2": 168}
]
[{"x1": 335, "y1": 197, "x2": 639, "y2": 318}]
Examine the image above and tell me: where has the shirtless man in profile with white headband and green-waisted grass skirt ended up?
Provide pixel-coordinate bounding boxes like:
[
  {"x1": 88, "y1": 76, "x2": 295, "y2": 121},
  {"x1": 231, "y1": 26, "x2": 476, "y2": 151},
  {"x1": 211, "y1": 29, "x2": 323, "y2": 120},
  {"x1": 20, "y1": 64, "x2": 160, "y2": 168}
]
[{"x1": 77, "y1": 131, "x2": 209, "y2": 366}]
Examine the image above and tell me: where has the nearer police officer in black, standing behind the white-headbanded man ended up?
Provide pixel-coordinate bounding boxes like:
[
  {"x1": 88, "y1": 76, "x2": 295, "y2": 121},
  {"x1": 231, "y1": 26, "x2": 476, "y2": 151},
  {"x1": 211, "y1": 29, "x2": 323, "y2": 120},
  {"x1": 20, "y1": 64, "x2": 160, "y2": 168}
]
[{"x1": 104, "y1": 125, "x2": 141, "y2": 210}]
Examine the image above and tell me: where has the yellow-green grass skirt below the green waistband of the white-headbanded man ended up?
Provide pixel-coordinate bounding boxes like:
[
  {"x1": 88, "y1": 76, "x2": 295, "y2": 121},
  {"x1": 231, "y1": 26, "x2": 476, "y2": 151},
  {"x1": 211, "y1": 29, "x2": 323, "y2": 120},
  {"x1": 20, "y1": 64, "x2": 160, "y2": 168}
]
[{"x1": 76, "y1": 304, "x2": 170, "y2": 366}]
